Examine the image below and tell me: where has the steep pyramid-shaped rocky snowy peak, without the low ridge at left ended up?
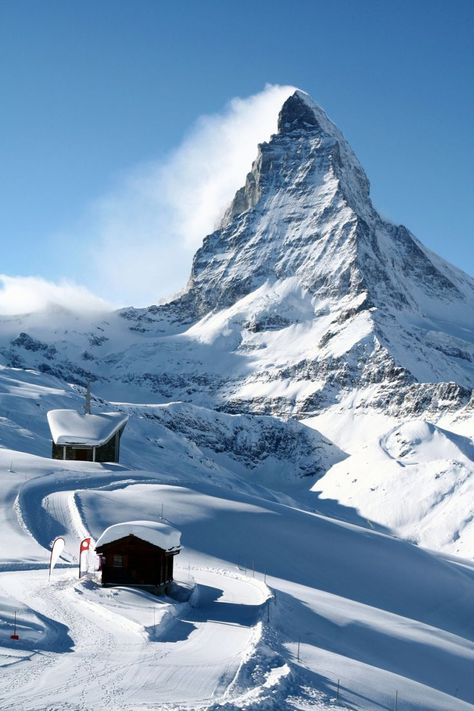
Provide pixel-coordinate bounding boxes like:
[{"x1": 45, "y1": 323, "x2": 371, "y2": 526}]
[{"x1": 160, "y1": 91, "x2": 474, "y2": 414}]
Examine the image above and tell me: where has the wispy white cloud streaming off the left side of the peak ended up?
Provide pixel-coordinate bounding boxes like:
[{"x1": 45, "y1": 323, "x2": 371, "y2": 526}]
[{"x1": 83, "y1": 85, "x2": 294, "y2": 305}]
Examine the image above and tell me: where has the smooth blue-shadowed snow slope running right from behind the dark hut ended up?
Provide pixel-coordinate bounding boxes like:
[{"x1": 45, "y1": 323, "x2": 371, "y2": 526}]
[{"x1": 79, "y1": 484, "x2": 474, "y2": 709}]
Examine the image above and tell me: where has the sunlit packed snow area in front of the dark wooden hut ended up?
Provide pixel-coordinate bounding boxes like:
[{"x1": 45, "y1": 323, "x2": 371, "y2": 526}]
[{"x1": 0, "y1": 570, "x2": 265, "y2": 711}]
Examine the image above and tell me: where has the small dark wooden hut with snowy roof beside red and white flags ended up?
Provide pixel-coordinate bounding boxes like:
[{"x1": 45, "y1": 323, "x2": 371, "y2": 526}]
[{"x1": 95, "y1": 521, "x2": 181, "y2": 590}]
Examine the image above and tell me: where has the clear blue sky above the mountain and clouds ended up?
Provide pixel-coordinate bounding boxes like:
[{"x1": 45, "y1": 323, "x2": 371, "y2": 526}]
[{"x1": 0, "y1": 0, "x2": 474, "y2": 303}]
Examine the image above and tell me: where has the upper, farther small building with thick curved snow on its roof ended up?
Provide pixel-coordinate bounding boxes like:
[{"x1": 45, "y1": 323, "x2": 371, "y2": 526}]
[{"x1": 48, "y1": 410, "x2": 128, "y2": 462}]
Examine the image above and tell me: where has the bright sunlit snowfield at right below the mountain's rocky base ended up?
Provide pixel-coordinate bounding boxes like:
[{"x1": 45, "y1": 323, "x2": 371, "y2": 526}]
[{"x1": 308, "y1": 413, "x2": 474, "y2": 559}]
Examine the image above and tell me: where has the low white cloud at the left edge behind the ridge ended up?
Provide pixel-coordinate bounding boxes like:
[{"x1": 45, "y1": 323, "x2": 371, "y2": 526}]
[{"x1": 0, "y1": 274, "x2": 110, "y2": 315}]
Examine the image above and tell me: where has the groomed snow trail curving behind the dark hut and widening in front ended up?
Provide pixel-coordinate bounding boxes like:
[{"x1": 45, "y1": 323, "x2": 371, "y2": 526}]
[{"x1": 0, "y1": 470, "x2": 267, "y2": 711}]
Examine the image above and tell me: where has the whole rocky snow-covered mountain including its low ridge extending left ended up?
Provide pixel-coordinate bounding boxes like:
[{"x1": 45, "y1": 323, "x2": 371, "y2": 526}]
[{"x1": 0, "y1": 91, "x2": 474, "y2": 417}]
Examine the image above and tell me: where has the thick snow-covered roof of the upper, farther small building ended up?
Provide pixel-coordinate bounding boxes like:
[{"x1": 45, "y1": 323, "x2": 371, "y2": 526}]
[{"x1": 48, "y1": 410, "x2": 128, "y2": 447}]
